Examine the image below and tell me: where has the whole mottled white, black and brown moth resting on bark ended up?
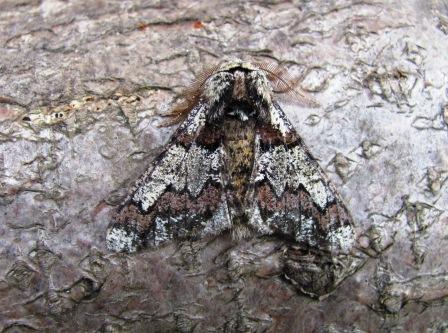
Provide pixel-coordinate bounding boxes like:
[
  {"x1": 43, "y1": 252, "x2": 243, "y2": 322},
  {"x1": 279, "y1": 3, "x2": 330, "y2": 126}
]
[{"x1": 106, "y1": 60, "x2": 354, "y2": 252}]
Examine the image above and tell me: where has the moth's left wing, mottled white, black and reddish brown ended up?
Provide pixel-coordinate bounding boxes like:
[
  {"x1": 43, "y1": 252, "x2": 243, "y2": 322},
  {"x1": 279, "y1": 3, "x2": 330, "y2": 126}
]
[{"x1": 106, "y1": 103, "x2": 230, "y2": 252}]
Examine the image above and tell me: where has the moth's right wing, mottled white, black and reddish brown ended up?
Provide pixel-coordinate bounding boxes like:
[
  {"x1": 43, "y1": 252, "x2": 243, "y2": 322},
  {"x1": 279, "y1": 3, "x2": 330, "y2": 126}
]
[{"x1": 248, "y1": 102, "x2": 354, "y2": 251}]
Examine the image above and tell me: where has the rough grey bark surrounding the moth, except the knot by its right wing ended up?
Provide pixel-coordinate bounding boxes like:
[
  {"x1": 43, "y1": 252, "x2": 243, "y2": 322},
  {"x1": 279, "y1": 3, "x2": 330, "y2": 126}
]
[{"x1": 0, "y1": 0, "x2": 448, "y2": 332}]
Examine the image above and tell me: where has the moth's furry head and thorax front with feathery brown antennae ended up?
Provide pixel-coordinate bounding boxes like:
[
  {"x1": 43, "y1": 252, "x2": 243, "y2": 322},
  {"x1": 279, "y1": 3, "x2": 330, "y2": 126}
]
[{"x1": 165, "y1": 59, "x2": 318, "y2": 123}]
